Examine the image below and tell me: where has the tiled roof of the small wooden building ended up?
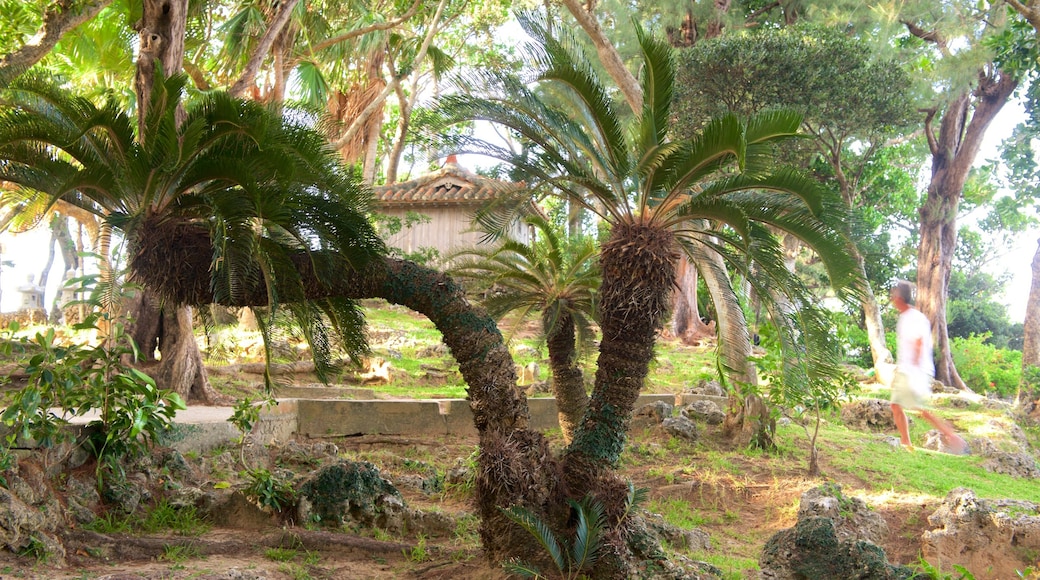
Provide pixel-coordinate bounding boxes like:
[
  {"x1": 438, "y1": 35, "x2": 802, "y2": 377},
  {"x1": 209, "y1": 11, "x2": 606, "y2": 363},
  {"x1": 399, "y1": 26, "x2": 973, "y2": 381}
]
[{"x1": 372, "y1": 162, "x2": 523, "y2": 207}]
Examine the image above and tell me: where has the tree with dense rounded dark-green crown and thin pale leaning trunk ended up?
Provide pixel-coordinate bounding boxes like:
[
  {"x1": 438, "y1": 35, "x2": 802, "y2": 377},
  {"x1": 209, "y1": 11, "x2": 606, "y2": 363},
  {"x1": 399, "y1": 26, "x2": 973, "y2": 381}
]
[{"x1": 676, "y1": 26, "x2": 913, "y2": 366}]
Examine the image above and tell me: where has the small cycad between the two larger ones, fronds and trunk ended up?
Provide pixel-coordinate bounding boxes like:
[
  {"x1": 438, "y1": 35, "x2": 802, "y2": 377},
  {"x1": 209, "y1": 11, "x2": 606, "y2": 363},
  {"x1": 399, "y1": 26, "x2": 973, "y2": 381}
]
[{"x1": 450, "y1": 215, "x2": 599, "y2": 443}]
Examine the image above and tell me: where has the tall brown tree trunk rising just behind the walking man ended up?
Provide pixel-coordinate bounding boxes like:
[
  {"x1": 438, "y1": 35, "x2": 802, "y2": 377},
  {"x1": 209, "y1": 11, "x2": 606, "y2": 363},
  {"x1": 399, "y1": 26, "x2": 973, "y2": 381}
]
[{"x1": 917, "y1": 70, "x2": 1018, "y2": 390}]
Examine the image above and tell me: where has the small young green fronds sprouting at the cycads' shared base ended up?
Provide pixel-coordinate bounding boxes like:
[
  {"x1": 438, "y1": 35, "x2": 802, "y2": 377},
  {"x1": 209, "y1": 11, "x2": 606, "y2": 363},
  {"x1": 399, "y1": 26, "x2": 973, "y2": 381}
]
[{"x1": 501, "y1": 496, "x2": 606, "y2": 580}]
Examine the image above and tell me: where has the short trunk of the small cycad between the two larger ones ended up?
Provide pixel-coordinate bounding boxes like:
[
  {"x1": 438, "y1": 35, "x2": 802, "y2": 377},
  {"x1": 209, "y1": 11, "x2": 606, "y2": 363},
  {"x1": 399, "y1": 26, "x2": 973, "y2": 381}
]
[{"x1": 542, "y1": 315, "x2": 589, "y2": 444}]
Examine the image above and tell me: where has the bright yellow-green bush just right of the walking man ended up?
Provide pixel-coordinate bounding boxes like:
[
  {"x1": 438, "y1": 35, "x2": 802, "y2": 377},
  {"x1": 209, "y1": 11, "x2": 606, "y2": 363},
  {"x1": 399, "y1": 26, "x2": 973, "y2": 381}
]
[{"x1": 950, "y1": 333, "x2": 1022, "y2": 397}]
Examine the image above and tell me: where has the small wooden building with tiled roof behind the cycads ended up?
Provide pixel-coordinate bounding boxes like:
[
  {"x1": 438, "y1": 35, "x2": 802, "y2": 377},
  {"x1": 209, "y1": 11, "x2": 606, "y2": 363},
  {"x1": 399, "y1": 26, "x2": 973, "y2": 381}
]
[{"x1": 372, "y1": 155, "x2": 528, "y2": 262}]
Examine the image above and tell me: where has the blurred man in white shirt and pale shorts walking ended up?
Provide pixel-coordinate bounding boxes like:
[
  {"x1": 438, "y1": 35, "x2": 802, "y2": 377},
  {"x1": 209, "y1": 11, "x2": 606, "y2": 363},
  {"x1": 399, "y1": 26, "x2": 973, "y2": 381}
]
[{"x1": 889, "y1": 281, "x2": 968, "y2": 455}]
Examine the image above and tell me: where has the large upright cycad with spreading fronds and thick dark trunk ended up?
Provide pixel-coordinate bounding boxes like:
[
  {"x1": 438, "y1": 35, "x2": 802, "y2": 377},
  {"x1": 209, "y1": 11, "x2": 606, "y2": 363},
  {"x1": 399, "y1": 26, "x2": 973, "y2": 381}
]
[{"x1": 444, "y1": 18, "x2": 855, "y2": 478}]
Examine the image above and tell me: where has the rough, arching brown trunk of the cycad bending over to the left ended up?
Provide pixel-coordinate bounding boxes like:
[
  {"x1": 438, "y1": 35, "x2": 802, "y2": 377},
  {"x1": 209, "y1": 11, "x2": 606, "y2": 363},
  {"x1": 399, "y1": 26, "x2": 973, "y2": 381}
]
[{"x1": 130, "y1": 225, "x2": 567, "y2": 562}]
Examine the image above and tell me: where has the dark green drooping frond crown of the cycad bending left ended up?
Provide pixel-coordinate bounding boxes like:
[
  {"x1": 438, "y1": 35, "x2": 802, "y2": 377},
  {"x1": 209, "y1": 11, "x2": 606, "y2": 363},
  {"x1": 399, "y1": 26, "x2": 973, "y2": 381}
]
[{"x1": 0, "y1": 70, "x2": 383, "y2": 384}]
